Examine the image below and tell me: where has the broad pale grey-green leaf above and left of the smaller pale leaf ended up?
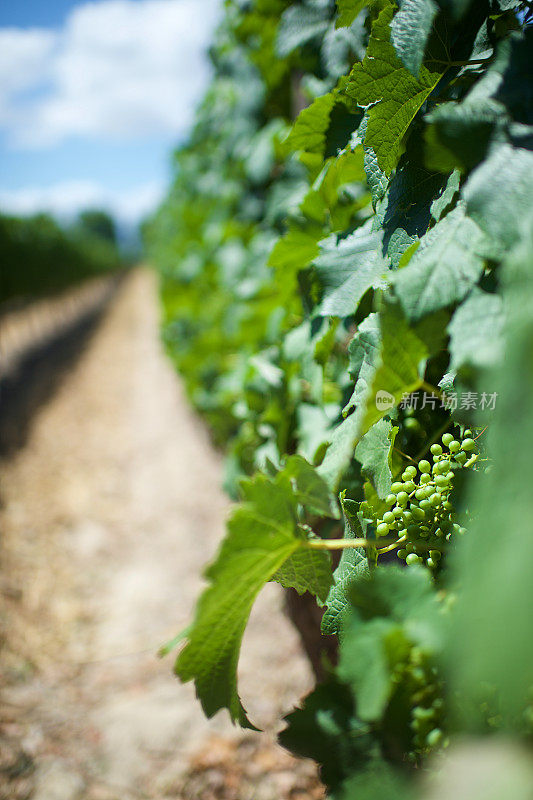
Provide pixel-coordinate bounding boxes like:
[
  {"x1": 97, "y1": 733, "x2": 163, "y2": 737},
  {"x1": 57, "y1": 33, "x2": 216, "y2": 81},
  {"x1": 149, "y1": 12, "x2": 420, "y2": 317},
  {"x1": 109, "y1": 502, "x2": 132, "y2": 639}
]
[{"x1": 392, "y1": 205, "x2": 489, "y2": 322}]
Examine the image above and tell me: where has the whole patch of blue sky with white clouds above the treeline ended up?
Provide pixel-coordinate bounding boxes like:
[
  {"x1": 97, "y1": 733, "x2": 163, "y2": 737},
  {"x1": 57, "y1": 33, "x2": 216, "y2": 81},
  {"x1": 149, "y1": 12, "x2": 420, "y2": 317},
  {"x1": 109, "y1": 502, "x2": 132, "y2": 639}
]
[{"x1": 0, "y1": 0, "x2": 221, "y2": 223}]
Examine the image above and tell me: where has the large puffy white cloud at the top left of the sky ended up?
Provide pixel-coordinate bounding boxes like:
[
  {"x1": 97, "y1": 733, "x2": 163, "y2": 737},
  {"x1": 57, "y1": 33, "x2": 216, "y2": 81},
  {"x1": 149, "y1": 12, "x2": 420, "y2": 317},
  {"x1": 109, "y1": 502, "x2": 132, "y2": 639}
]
[{"x1": 0, "y1": 0, "x2": 221, "y2": 148}]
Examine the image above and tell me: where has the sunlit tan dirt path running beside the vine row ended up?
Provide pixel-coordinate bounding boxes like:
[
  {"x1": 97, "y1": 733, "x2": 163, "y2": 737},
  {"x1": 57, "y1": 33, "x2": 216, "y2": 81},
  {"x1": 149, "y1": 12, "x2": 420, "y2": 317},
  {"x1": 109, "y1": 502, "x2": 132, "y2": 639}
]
[{"x1": 0, "y1": 271, "x2": 313, "y2": 800}]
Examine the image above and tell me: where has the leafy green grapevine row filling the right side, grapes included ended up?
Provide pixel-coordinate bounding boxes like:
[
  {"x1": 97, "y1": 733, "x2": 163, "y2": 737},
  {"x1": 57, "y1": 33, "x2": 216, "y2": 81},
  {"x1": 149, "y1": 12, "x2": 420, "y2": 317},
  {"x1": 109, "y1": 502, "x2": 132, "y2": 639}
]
[{"x1": 146, "y1": 0, "x2": 533, "y2": 800}]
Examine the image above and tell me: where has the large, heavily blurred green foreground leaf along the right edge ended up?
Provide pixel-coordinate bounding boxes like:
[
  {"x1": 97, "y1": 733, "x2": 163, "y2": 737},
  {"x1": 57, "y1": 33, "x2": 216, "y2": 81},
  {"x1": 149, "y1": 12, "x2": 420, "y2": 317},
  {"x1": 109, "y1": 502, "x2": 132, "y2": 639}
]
[{"x1": 447, "y1": 222, "x2": 533, "y2": 720}]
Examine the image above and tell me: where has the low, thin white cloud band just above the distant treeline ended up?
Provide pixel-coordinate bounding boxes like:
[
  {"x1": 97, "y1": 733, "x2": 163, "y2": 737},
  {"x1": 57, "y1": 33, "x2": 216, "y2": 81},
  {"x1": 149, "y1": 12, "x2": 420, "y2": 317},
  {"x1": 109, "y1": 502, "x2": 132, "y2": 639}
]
[{"x1": 0, "y1": 181, "x2": 164, "y2": 225}]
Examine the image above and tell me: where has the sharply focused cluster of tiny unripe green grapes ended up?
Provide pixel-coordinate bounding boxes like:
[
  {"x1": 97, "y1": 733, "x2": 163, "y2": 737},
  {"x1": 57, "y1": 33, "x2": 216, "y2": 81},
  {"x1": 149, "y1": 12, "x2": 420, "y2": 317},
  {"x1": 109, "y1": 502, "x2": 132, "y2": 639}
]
[{"x1": 364, "y1": 430, "x2": 477, "y2": 570}]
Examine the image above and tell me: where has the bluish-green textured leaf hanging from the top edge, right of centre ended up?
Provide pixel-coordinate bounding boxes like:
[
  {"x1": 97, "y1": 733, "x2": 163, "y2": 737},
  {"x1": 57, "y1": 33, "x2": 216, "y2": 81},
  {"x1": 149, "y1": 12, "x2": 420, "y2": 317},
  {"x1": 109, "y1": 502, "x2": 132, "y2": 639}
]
[{"x1": 391, "y1": 0, "x2": 438, "y2": 78}]
